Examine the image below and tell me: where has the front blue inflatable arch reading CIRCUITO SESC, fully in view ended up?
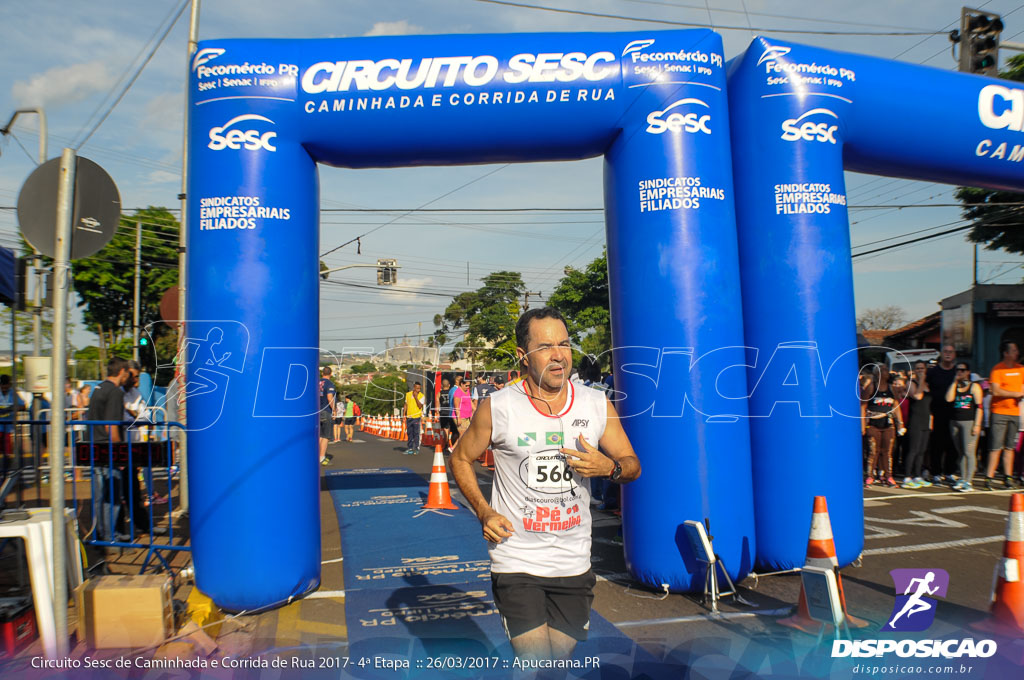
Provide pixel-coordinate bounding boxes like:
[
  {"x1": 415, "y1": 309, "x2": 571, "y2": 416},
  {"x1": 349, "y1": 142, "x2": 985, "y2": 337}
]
[{"x1": 187, "y1": 30, "x2": 755, "y2": 610}]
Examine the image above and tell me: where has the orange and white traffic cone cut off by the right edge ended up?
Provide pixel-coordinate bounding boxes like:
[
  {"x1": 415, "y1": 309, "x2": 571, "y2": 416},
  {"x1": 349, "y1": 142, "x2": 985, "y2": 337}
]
[{"x1": 971, "y1": 494, "x2": 1024, "y2": 638}]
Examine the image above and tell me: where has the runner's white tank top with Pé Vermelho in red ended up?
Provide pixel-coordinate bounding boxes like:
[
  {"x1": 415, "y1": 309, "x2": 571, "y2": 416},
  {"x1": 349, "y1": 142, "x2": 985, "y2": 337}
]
[{"x1": 488, "y1": 382, "x2": 608, "y2": 578}]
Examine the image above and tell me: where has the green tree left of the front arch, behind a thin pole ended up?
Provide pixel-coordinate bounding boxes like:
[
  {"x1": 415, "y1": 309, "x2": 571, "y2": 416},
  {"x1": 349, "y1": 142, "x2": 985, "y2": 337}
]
[{"x1": 73, "y1": 207, "x2": 180, "y2": 372}]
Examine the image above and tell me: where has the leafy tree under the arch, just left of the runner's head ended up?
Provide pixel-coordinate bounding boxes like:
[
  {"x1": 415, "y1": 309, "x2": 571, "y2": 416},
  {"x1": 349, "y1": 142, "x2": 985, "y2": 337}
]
[{"x1": 434, "y1": 271, "x2": 526, "y2": 369}]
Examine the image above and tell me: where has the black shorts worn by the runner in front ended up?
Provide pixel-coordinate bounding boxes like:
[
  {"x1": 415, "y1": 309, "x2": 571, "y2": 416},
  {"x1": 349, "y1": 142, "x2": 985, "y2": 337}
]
[{"x1": 490, "y1": 571, "x2": 597, "y2": 641}]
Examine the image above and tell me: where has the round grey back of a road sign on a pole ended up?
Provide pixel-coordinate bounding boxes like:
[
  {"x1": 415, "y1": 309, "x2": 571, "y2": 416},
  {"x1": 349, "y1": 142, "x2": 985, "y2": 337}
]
[{"x1": 17, "y1": 156, "x2": 121, "y2": 260}]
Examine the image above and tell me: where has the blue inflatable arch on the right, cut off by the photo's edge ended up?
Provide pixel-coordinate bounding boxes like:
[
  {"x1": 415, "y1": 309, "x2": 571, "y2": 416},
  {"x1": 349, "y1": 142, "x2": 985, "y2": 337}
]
[{"x1": 729, "y1": 38, "x2": 1024, "y2": 569}]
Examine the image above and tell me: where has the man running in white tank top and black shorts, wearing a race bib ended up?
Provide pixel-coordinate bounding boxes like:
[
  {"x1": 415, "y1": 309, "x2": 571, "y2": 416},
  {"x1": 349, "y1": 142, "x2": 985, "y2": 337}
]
[{"x1": 452, "y1": 307, "x2": 640, "y2": 660}]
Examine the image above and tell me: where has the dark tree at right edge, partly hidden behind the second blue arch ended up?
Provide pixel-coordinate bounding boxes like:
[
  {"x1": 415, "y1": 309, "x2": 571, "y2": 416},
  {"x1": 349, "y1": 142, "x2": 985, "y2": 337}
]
[{"x1": 953, "y1": 54, "x2": 1024, "y2": 254}]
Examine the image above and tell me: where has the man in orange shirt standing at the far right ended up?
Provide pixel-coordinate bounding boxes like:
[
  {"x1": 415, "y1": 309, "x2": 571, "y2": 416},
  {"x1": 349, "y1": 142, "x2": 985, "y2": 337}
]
[{"x1": 985, "y1": 342, "x2": 1024, "y2": 491}]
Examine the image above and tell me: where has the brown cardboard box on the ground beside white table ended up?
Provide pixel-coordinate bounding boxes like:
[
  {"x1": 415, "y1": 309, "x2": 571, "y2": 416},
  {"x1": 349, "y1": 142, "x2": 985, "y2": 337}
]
[{"x1": 75, "y1": 575, "x2": 174, "y2": 649}]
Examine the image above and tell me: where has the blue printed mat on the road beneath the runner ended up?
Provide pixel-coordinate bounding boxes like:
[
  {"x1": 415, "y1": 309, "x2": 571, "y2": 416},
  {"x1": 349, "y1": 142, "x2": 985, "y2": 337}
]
[{"x1": 324, "y1": 468, "x2": 678, "y2": 680}]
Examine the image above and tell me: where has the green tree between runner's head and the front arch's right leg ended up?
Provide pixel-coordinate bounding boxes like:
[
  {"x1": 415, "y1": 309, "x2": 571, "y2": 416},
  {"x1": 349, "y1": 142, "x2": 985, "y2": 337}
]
[{"x1": 548, "y1": 252, "x2": 611, "y2": 363}]
